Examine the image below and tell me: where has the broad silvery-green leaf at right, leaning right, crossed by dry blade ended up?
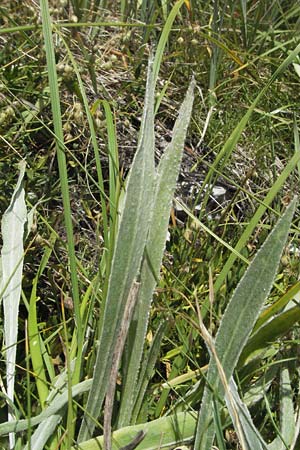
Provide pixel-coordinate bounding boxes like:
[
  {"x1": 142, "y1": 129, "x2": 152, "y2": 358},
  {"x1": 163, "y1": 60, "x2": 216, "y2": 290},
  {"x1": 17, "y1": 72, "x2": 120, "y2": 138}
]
[{"x1": 195, "y1": 199, "x2": 296, "y2": 450}]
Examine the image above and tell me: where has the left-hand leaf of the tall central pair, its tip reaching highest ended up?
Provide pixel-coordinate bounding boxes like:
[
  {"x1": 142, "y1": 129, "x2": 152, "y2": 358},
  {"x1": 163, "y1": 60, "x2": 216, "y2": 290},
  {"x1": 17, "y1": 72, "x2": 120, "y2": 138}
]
[{"x1": 78, "y1": 57, "x2": 154, "y2": 442}]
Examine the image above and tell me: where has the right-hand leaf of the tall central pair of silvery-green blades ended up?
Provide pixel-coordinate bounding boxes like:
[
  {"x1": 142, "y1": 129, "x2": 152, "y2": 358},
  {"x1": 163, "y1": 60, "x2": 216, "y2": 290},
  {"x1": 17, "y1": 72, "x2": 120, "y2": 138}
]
[{"x1": 118, "y1": 81, "x2": 195, "y2": 427}]
